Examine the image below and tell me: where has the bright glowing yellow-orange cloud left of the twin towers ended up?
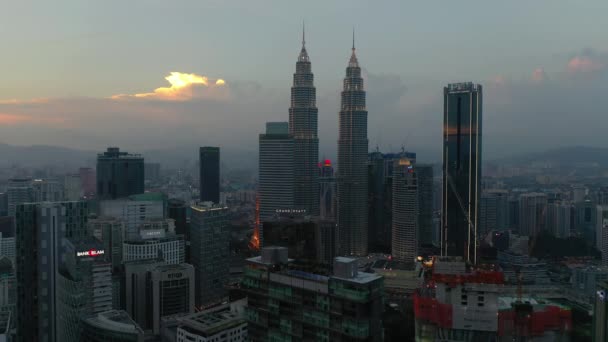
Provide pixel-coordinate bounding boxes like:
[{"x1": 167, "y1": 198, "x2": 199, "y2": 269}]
[{"x1": 111, "y1": 71, "x2": 226, "y2": 101}]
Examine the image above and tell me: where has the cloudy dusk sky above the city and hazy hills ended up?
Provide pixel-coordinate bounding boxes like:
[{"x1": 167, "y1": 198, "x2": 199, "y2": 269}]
[{"x1": 0, "y1": 0, "x2": 608, "y2": 160}]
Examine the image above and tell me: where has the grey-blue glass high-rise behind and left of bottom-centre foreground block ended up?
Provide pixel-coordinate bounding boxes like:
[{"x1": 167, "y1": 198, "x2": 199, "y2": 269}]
[{"x1": 190, "y1": 205, "x2": 230, "y2": 307}]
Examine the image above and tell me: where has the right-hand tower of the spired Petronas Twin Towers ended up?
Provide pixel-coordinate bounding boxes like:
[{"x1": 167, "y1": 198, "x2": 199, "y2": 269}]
[{"x1": 338, "y1": 35, "x2": 369, "y2": 256}]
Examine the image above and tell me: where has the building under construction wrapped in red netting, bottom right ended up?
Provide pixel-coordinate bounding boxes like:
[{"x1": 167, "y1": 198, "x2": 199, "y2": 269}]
[{"x1": 413, "y1": 257, "x2": 572, "y2": 342}]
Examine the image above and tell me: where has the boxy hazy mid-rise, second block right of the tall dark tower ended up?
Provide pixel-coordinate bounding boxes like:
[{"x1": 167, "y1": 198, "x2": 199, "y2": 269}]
[{"x1": 519, "y1": 192, "x2": 547, "y2": 237}]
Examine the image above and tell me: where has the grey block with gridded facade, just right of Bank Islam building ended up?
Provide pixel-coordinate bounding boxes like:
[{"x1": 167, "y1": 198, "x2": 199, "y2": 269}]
[{"x1": 125, "y1": 259, "x2": 190, "y2": 334}]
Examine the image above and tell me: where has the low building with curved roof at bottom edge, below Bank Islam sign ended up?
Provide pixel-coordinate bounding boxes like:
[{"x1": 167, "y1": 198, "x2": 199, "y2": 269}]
[{"x1": 81, "y1": 310, "x2": 144, "y2": 342}]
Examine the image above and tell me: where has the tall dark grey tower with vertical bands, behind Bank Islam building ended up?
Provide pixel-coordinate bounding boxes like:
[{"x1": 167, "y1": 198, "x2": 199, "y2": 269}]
[{"x1": 15, "y1": 202, "x2": 88, "y2": 342}]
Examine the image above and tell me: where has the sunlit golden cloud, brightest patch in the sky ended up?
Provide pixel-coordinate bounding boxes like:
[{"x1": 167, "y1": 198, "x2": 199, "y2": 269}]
[{"x1": 110, "y1": 71, "x2": 227, "y2": 101}]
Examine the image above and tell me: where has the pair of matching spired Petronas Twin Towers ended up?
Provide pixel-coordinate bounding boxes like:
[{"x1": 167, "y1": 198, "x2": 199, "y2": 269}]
[{"x1": 289, "y1": 28, "x2": 368, "y2": 256}]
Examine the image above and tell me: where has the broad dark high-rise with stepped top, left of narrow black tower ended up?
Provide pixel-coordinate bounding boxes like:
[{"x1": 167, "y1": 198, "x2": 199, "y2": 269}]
[{"x1": 97, "y1": 147, "x2": 144, "y2": 199}]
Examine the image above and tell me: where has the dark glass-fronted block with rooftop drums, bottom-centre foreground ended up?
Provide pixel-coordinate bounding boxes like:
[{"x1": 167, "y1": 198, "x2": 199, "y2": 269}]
[{"x1": 241, "y1": 247, "x2": 384, "y2": 341}]
